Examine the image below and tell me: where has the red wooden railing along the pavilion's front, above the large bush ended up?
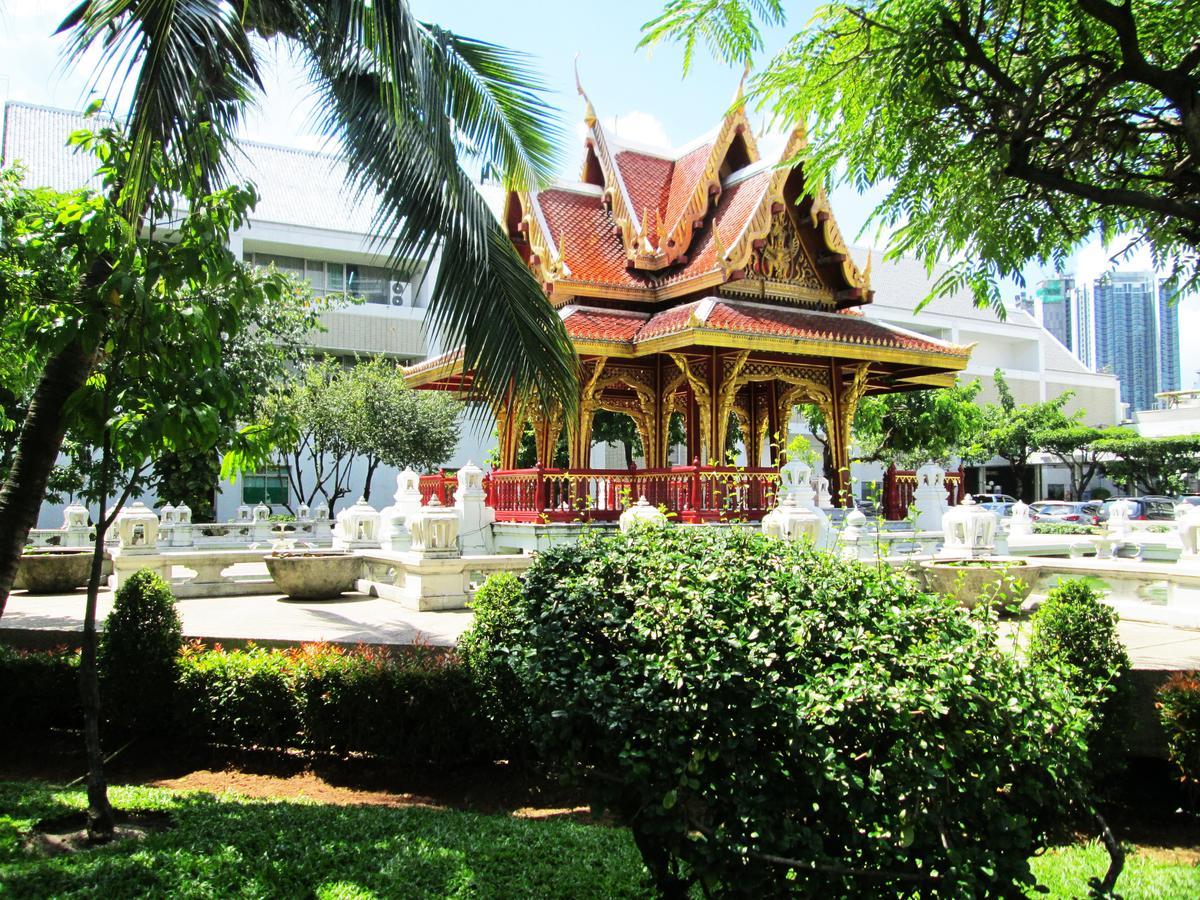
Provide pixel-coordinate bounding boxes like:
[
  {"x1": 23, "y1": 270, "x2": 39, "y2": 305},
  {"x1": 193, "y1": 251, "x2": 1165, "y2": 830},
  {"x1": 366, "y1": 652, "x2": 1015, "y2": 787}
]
[{"x1": 486, "y1": 463, "x2": 779, "y2": 522}]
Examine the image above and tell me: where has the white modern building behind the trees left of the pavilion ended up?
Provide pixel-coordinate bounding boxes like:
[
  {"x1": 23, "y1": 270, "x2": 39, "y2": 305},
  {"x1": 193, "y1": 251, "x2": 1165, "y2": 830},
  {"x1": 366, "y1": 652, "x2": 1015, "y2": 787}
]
[{"x1": 0, "y1": 102, "x2": 491, "y2": 527}]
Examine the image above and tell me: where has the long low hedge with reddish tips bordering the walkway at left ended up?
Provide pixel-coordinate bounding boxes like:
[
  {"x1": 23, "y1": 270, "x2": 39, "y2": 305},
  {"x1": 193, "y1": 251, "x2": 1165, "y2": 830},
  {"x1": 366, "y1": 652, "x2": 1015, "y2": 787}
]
[{"x1": 0, "y1": 644, "x2": 503, "y2": 763}]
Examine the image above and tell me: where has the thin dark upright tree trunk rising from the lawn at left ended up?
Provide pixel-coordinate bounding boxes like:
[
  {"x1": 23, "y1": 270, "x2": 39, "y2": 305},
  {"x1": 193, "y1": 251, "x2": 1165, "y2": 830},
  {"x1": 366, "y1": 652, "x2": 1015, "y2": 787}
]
[{"x1": 79, "y1": 446, "x2": 116, "y2": 844}]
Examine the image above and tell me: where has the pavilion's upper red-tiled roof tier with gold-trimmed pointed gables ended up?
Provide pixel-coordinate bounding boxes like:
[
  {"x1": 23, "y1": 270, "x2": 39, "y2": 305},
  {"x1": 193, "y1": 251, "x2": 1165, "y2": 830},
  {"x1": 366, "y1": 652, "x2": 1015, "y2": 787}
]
[{"x1": 504, "y1": 83, "x2": 872, "y2": 306}]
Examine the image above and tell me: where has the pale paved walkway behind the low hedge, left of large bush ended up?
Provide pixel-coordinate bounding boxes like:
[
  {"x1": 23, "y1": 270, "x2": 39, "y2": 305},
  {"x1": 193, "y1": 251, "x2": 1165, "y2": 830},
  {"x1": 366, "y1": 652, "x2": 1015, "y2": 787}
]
[{"x1": 0, "y1": 590, "x2": 470, "y2": 647}]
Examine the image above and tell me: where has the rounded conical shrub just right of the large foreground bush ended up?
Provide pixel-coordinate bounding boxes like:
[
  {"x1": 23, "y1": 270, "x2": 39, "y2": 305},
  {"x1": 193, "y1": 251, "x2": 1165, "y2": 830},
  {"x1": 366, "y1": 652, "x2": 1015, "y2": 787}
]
[{"x1": 1030, "y1": 581, "x2": 1133, "y2": 780}]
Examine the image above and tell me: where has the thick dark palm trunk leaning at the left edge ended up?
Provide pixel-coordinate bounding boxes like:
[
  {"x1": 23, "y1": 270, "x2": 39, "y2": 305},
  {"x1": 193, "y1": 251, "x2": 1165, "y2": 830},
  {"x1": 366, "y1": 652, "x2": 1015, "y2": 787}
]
[{"x1": 0, "y1": 340, "x2": 103, "y2": 616}]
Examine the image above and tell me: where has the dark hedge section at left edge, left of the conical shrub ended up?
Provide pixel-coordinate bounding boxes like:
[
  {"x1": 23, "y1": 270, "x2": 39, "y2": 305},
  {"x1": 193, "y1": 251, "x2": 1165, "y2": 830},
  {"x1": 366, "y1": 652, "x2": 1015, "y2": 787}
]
[{"x1": 0, "y1": 644, "x2": 83, "y2": 740}]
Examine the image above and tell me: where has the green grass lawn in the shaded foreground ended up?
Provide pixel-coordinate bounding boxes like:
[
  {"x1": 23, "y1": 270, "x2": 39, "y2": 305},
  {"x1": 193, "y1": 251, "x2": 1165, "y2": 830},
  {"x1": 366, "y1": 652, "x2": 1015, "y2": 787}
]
[{"x1": 0, "y1": 782, "x2": 1200, "y2": 900}]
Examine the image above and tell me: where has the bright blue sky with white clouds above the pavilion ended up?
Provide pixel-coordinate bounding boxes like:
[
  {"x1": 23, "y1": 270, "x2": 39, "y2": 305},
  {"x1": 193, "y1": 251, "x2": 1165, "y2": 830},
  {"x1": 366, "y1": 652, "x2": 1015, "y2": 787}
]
[{"x1": 0, "y1": 0, "x2": 1200, "y2": 388}]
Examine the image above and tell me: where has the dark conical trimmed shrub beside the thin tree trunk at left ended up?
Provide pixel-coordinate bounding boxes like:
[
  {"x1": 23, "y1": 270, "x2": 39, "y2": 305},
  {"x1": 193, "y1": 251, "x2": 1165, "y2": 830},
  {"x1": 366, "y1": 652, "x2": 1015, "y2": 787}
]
[{"x1": 98, "y1": 569, "x2": 184, "y2": 734}]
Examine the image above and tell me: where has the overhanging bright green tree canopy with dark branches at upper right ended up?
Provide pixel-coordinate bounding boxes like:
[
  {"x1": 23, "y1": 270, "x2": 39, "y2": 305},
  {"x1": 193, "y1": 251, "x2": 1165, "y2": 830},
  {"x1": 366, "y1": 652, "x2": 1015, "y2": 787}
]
[{"x1": 643, "y1": 0, "x2": 1200, "y2": 311}]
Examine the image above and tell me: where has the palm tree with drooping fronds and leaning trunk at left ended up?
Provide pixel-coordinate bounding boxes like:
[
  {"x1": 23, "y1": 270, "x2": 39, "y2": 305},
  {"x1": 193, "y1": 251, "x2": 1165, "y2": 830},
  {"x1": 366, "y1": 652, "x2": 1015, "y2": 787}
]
[{"x1": 0, "y1": 0, "x2": 576, "y2": 614}]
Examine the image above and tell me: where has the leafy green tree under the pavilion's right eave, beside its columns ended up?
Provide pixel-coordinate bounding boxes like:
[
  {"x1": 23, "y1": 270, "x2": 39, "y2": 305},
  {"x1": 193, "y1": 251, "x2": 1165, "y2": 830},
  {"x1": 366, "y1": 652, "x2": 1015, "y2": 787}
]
[{"x1": 852, "y1": 379, "x2": 984, "y2": 468}]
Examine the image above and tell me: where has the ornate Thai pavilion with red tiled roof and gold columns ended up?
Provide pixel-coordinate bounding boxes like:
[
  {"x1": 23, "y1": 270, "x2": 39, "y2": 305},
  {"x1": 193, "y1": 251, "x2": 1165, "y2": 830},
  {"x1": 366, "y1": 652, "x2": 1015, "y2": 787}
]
[{"x1": 406, "y1": 90, "x2": 970, "y2": 521}]
